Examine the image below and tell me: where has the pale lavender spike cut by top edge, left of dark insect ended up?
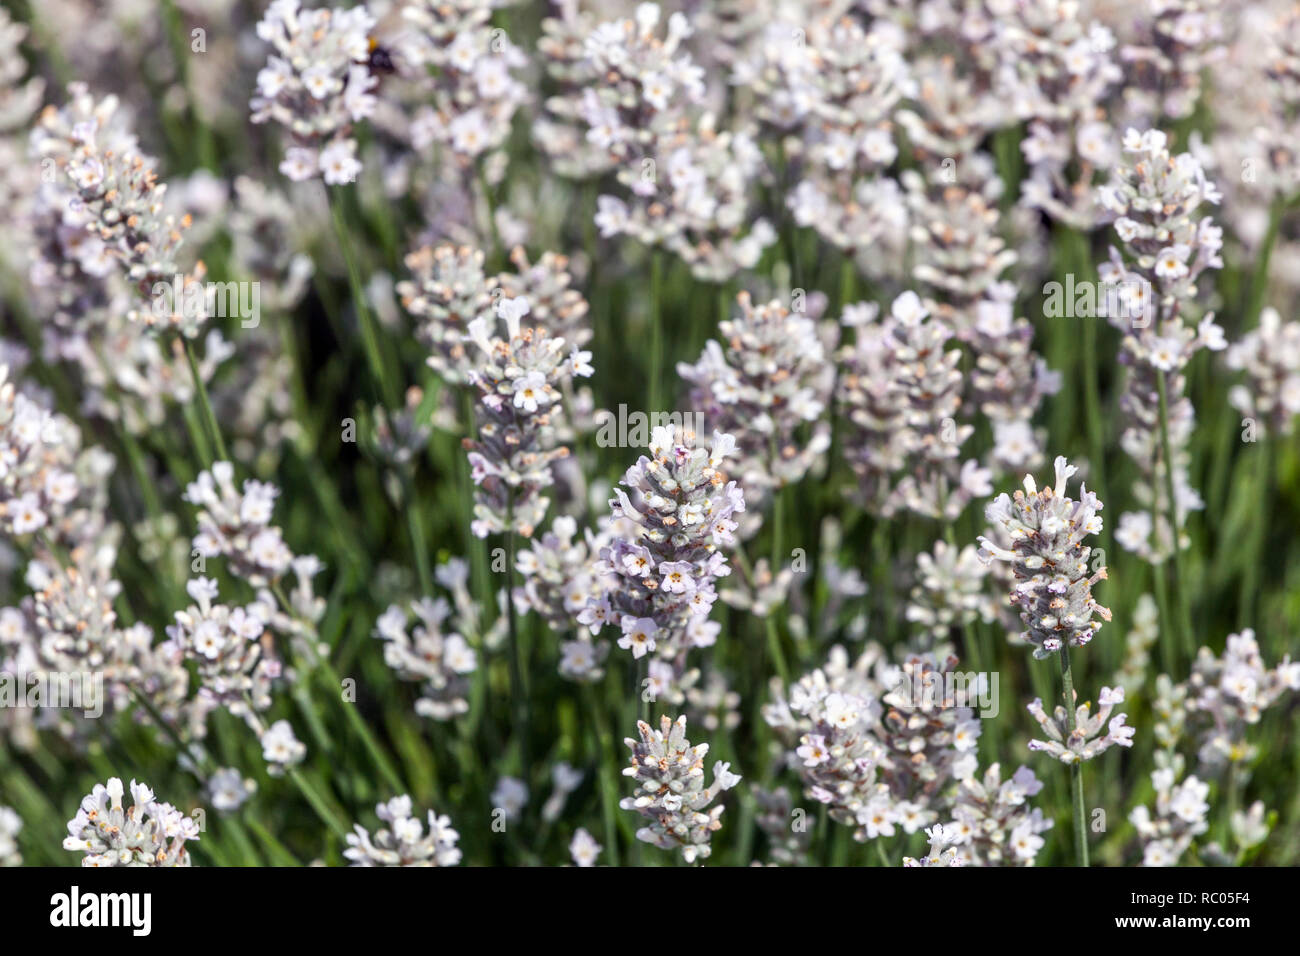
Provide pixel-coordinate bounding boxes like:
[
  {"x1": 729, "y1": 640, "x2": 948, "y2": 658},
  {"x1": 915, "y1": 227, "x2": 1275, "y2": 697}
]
[{"x1": 250, "y1": 0, "x2": 378, "y2": 185}]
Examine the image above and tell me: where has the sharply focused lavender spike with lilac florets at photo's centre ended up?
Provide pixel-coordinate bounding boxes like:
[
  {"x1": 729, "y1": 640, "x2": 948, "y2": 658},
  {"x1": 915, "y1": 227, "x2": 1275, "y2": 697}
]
[{"x1": 579, "y1": 425, "x2": 745, "y2": 658}]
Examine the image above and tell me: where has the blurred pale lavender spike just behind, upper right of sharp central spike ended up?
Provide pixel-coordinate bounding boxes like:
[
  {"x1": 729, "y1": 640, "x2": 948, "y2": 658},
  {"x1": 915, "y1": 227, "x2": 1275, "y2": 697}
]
[{"x1": 677, "y1": 293, "x2": 836, "y2": 507}]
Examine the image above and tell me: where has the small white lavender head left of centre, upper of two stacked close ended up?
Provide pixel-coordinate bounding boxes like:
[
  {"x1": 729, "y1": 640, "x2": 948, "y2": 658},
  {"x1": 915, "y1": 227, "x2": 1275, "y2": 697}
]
[{"x1": 185, "y1": 462, "x2": 294, "y2": 588}]
